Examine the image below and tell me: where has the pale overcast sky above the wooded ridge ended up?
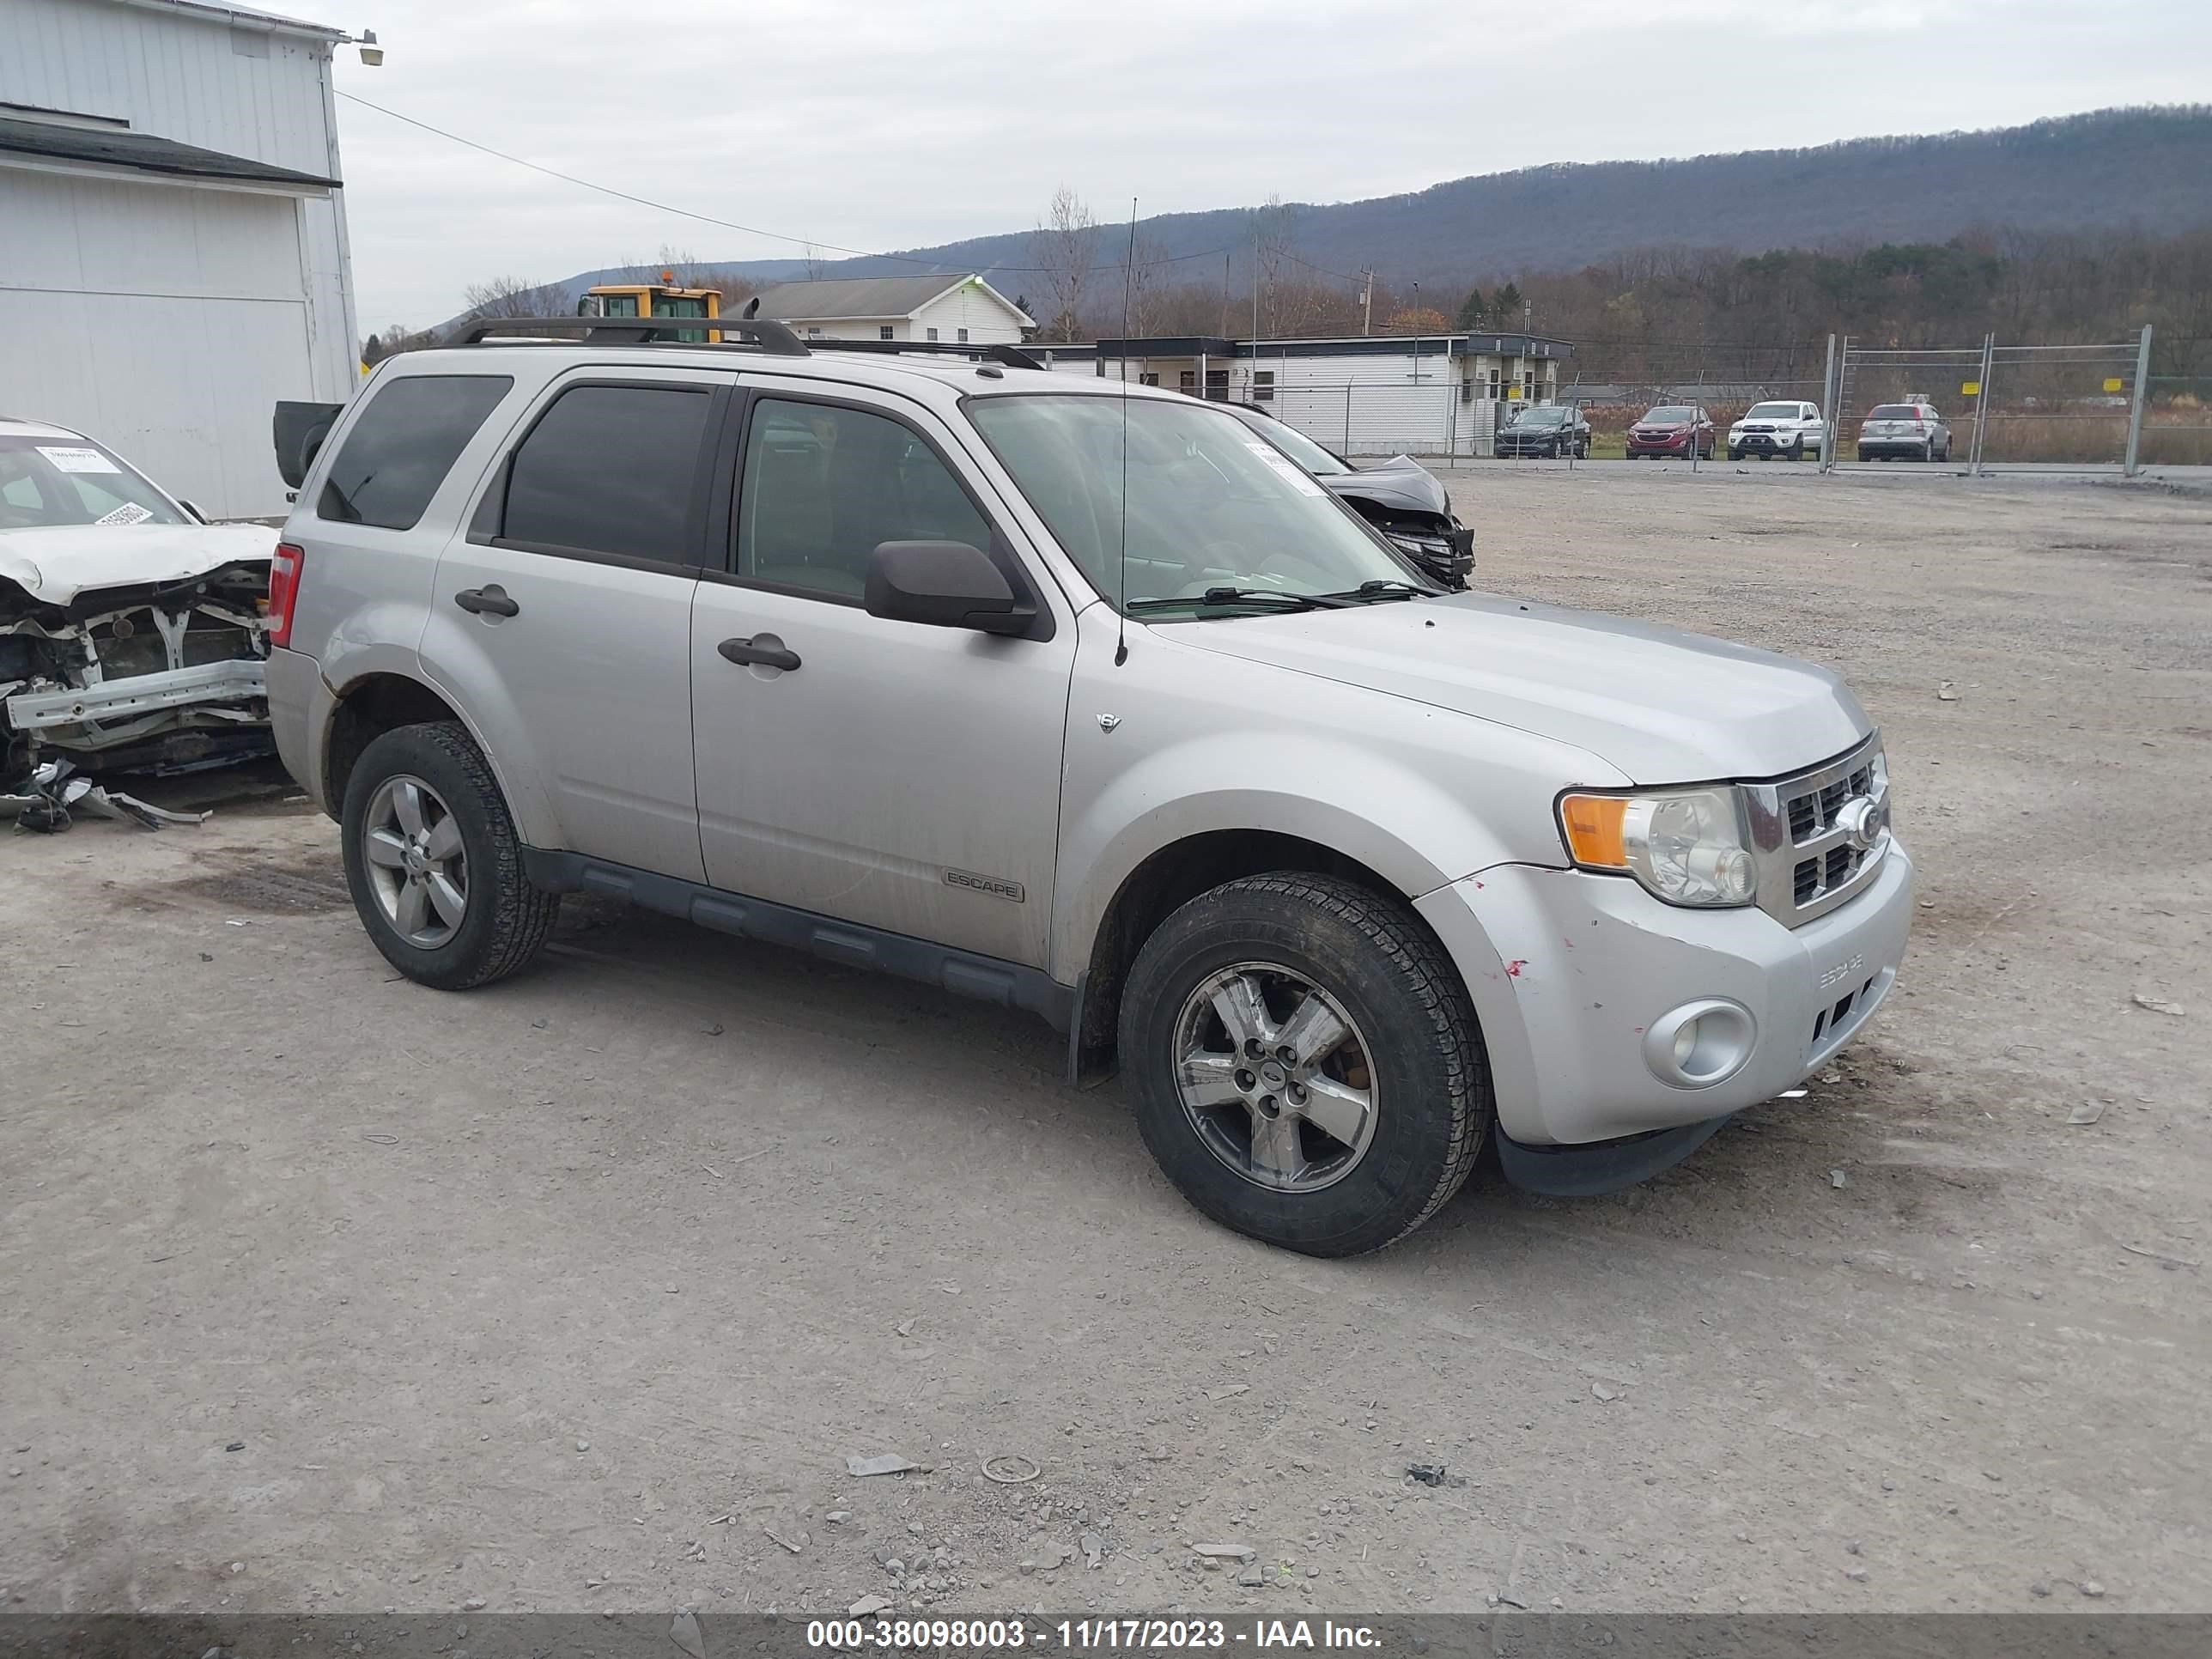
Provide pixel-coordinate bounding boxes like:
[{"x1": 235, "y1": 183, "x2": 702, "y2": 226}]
[{"x1": 298, "y1": 0, "x2": 2212, "y2": 330}]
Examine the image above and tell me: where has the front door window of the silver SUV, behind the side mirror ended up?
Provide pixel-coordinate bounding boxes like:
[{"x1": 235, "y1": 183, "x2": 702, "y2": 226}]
[{"x1": 737, "y1": 398, "x2": 991, "y2": 599}]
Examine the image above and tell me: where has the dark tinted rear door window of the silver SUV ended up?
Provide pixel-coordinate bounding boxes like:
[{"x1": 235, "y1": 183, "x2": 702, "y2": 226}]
[{"x1": 500, "y1": 385, "x2": 712, "y2": 564}]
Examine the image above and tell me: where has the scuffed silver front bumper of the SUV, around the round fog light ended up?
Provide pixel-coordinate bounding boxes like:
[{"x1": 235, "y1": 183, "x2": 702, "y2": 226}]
[{"x1": 1416, "y1": 842, "x2": 1913, "y2": 1146}]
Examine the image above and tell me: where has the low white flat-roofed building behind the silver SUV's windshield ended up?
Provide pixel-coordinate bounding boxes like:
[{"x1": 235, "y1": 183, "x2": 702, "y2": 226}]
[{"x1": 1029, "y1": 334, "x2": 1575, "y2": 456}]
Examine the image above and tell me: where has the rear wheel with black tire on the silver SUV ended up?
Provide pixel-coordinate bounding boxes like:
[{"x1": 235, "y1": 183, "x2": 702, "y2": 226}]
[{"x1": 338, "y1": 721, "x2": 560, "y2": 991}]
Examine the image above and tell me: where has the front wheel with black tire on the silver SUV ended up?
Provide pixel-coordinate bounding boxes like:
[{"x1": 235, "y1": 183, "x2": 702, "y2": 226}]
[{"x1": 1119, "y1": 872, "x2": 1491, "y2": 1256}]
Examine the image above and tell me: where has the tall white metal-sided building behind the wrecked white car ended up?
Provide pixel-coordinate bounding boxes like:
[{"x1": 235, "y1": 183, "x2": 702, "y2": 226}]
[{"x1": 0, "y1": 0, "x2": 358, "y2": 518}]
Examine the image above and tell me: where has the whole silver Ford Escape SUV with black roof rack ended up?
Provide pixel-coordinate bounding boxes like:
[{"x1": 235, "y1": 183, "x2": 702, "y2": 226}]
[{"x1": 268, "y1": 319, "x2": 1913, "y2": 1255}]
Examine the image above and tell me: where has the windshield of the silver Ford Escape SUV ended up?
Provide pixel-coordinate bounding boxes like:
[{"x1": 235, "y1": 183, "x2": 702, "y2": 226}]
[{"x1": 969, "y1": 392, "x2": 1427, "y2": 619}]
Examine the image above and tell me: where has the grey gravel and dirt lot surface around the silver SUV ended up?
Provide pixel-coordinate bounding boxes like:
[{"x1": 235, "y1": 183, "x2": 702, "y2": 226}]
[{"x1": 0, "y1": 467, "x2": 2212, "y2": 1613}]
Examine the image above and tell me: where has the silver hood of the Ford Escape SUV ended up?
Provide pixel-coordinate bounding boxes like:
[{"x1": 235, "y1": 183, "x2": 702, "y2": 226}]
[{"x1": 1164, "y1": 592, "x2": 1871, "y2": 783}]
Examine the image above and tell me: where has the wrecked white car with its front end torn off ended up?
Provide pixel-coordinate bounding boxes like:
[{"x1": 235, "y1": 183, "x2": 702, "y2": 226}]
[{"x1": 0, "y1": 418, "x2": 276, "y2": 790}]
